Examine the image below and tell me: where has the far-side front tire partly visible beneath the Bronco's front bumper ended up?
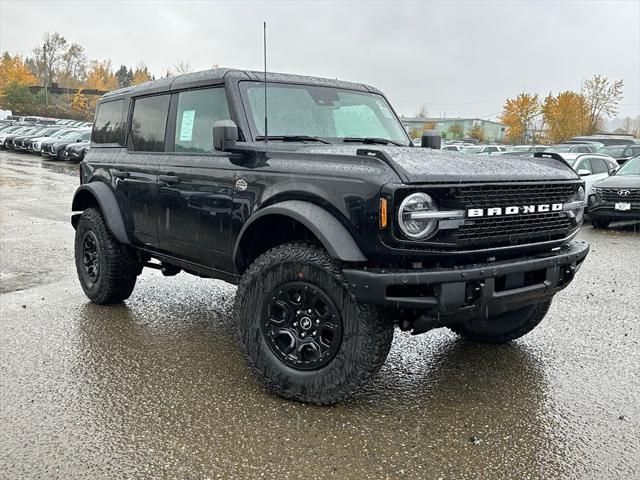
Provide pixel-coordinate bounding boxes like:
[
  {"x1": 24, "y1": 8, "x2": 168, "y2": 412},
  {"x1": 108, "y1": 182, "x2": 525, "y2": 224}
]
[{"x1": 449, "y1": 299, "x2": 551, "y2": 343}]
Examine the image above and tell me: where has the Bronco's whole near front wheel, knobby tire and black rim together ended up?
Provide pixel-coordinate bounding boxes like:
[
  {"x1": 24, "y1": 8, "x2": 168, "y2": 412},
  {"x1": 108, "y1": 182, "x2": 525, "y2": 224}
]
[{"x1": 234, "y1": 243, "x2": 393, "y2": 404}]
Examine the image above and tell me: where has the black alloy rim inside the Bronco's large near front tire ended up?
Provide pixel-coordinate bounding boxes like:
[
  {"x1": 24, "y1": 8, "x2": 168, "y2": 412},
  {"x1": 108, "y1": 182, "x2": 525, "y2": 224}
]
[{"x1": 262, "y1": 281, "x2": 342, "y2": 370}]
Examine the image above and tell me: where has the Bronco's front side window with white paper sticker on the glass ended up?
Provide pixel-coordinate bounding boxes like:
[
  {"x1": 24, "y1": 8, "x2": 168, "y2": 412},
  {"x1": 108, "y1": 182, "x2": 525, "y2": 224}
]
[{"x1": 175, "y1": 87, "x2": 231, "y2": 153}]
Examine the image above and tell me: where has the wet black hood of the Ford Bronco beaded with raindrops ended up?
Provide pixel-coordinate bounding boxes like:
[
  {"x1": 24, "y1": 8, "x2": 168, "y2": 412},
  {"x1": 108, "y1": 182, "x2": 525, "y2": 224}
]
[{"x1": 290, "y1": 143, "x2": 579, "y2": 184}]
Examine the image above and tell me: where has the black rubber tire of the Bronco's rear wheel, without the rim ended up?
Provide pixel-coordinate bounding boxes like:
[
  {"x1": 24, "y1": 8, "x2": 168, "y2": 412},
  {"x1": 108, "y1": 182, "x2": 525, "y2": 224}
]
[{"x1": 75, "y1": 208, "x2": 139, "y2": 305}]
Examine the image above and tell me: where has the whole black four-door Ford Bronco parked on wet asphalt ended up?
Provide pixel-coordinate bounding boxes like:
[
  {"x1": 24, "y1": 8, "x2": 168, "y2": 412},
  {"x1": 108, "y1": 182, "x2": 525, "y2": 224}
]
[{"x1": 72, "y1": 69, "x2": 589, "y2": 404}]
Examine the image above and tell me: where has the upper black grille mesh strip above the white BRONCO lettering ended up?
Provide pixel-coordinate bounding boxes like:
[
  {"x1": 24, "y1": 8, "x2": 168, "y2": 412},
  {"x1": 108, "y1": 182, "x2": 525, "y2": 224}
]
[{"x1": 455, "y1": 183, "x2": 578, "y2": 208}]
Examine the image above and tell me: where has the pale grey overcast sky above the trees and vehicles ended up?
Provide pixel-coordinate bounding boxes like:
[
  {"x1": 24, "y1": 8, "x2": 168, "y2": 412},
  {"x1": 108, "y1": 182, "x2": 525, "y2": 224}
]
[{"x1": 0, "y1": 0, "x2": 640, "y2": 118}]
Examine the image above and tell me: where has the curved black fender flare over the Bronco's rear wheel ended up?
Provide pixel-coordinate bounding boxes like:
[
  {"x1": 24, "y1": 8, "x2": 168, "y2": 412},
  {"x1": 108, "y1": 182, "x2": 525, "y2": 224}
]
[{"x1": 71, "y1": 182, "x2": 131, "y2": 245}]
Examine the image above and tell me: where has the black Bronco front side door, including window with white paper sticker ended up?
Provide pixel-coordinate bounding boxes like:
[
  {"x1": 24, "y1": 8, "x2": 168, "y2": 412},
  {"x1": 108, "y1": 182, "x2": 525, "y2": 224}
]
[{"x1": 157, "y1": 86, "x2": 236, "y2": 272}]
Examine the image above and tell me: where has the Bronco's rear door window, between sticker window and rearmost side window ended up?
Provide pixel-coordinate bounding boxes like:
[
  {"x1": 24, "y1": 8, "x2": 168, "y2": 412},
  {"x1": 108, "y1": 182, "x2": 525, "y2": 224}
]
[{"x1": 128, "y1": 95, "x2": 170, "y2": 152}]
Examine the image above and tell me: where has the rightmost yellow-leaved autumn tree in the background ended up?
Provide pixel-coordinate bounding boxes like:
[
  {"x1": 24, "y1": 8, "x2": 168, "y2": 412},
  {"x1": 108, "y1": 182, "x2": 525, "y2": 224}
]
[{"x1": 582, "y1": 75, "x2": 623, "y2": 133}]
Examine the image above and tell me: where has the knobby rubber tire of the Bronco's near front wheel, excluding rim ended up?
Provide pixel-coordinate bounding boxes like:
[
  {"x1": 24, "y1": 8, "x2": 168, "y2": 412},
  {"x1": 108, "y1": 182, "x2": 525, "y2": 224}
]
[{"x1": 234, "y1": 243, "x2": 394, "y2": 405}]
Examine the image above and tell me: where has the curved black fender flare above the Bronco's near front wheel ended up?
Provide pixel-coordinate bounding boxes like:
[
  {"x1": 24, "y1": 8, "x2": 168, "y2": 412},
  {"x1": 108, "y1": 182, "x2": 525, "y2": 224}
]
[{"x1": 233, "y1": 200, "x2": 367, "y2": 265}]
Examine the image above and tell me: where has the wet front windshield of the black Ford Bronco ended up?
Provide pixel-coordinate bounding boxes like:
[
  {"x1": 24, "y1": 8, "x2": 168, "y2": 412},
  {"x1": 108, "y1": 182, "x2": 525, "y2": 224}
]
[{"x1": 240, "y1": 82, "x2": 410, "y2": 145}]
